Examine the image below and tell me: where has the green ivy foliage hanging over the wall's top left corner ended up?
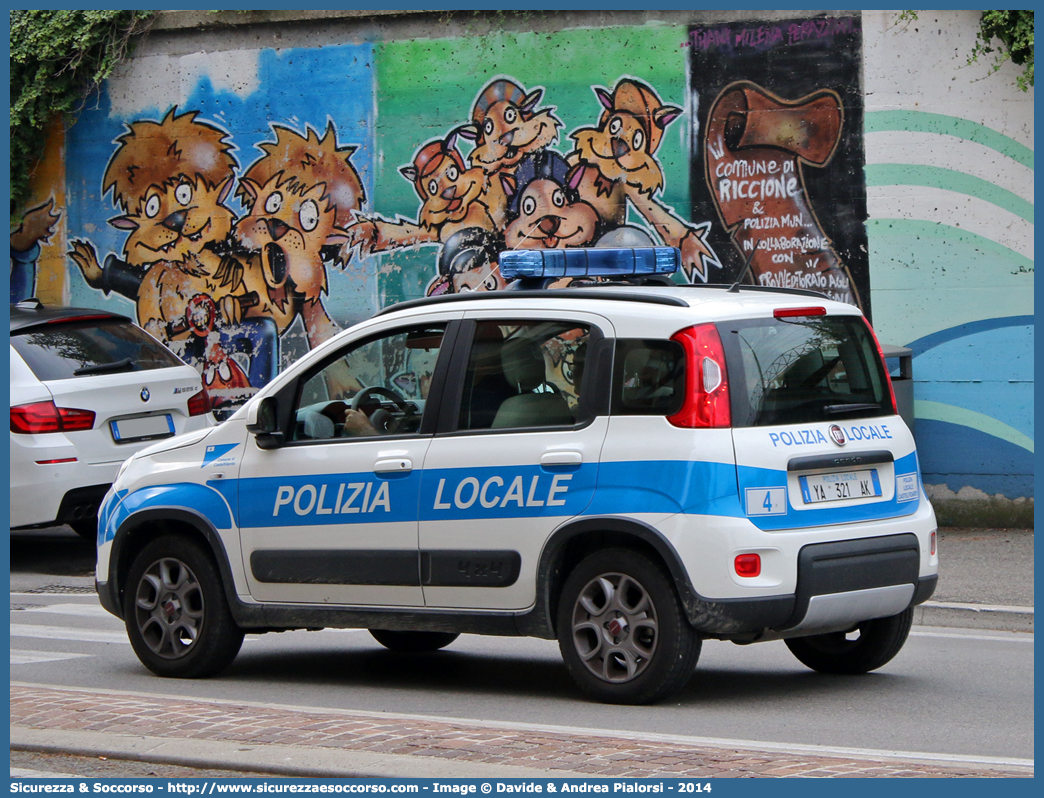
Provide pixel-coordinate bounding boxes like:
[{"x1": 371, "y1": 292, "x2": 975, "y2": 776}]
[{"x1": 10, "y1": 10, "x2": 156, "y2": 219}]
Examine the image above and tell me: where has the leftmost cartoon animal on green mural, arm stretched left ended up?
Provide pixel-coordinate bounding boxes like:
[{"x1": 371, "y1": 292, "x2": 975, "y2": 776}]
[{"x1": 345, "y1": 131, "x2": 496, "y2": 256}]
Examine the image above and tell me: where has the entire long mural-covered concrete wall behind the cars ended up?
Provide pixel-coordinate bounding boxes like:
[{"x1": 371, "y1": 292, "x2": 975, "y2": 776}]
[{"x1": 11, "y1": 11, "x2": 1033, "y2": 511}]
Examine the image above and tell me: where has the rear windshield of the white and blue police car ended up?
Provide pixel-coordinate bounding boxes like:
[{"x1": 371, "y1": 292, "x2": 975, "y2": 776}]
[{"x1": 717, "y1": 316, "x2": 893, "y2": 427}]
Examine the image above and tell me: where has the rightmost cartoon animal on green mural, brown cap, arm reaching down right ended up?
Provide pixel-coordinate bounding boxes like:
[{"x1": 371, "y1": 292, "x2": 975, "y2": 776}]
[{"x1": 568, "y1": 78, "x2": 721, "y2": 282}]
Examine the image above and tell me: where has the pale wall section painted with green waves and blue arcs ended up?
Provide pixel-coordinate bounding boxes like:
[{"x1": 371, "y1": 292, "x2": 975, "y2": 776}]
[{"x1": 862, "y1": 11, "x2": 1034, "y2": 518}]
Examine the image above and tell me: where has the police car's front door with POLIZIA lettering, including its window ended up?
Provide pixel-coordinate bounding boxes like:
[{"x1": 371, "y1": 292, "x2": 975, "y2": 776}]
[{"x1": 239, "y1": 322, "x2": 455, "y2": 606}]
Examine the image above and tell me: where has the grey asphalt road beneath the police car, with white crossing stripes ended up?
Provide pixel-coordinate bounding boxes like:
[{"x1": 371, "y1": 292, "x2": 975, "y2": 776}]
[{"x1": 10, "y1": 533, "x2": 1034, "y2": 759}]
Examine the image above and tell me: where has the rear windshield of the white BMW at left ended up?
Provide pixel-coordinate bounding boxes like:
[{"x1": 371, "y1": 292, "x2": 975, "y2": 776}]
[{"x1": 10, "y1": 321, "x2": 183, "y2": 382}]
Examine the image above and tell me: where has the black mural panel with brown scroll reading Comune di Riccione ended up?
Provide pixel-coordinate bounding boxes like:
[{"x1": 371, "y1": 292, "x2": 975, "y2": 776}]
[{"x1": 688, "y1": 18, "x2": 870, "y2": 314}]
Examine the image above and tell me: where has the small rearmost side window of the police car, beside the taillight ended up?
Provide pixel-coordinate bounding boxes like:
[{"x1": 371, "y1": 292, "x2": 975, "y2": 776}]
[{"x1": 612, "y1": 338, "x2": 685, "y2": 416}]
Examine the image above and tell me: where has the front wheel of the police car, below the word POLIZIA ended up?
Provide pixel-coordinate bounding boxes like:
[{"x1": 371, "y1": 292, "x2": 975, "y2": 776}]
[{"x1": 123, "y1": 535, "x2": 243, "y2": 679}]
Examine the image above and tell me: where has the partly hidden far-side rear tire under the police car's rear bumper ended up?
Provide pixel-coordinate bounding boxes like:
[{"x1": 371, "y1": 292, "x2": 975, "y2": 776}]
[{"x1": 784, "y1": 607, "x2": 914, "y2": 674}]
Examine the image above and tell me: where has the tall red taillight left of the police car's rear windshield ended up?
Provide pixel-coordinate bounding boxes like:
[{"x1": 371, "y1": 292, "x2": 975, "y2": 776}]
[{"x1": 667, "y1": 324, "x2": 732, "y2": 427}]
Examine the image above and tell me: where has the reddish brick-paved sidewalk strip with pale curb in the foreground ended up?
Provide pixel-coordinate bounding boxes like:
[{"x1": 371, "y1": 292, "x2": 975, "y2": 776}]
[{"x1": 10, "y1": 683, "x2": 1034, "y2": 779}]
